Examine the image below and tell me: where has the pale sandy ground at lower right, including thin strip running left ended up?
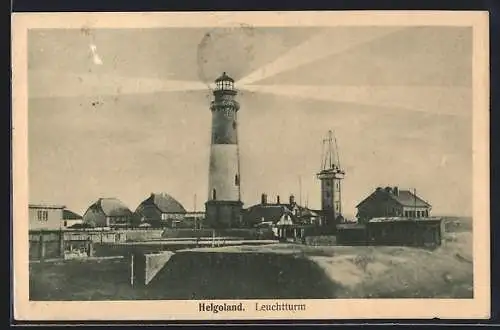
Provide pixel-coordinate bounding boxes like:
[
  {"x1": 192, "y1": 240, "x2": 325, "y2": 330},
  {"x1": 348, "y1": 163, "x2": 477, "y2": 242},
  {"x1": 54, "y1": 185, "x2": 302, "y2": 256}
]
[{"x1": 179, "y1": 232, "x2": 473, "y2": 298}]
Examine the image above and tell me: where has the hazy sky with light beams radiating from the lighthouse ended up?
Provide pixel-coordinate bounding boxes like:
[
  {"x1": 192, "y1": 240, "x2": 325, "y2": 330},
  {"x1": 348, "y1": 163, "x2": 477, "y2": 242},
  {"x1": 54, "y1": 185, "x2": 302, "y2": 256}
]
[{"x1": 28, "y1": 26, "x2": 472, "y2": 215}]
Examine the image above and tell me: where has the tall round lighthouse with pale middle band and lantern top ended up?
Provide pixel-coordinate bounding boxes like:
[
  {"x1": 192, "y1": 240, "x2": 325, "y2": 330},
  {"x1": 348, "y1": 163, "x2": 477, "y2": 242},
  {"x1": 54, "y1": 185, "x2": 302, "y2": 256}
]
[{"x1": 205, "y1": 72, "x2": 243, "y2": 228}]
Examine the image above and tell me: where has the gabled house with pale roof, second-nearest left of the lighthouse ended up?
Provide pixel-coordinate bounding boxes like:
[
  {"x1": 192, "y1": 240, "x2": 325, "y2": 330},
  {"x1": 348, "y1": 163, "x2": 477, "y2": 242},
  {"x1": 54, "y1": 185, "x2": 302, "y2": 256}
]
[{"x1": 83, "y1": 197, "x2": 133, "y2": 227}]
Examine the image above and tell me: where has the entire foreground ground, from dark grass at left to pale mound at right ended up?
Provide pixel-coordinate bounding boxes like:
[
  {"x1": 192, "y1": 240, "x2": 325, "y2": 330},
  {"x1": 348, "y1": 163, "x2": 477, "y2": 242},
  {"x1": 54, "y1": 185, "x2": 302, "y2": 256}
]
[{"x1": 30, "y1": 231, "x2": 473, "y2": 300}]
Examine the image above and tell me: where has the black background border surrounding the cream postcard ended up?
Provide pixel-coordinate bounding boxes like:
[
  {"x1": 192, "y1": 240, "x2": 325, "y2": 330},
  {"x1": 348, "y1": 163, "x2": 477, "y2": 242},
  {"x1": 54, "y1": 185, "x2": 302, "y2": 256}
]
[{"x1": 8, "y1": 0, "x2": 500, "y2": 327}]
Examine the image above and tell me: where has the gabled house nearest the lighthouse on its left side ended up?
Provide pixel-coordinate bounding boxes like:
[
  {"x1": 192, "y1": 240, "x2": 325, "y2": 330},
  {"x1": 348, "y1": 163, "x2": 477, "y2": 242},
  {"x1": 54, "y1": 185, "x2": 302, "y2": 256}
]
[{"x1": 134, "y1": 193, "x2": 187, "y2": 227}]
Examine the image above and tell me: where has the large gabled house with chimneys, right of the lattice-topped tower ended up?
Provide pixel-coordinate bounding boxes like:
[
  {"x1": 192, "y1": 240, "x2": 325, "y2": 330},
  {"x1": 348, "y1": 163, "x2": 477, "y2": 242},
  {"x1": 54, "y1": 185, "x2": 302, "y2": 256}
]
[{"x1": 356, "y1": 187, "x2": 432, "y2": 223}]
